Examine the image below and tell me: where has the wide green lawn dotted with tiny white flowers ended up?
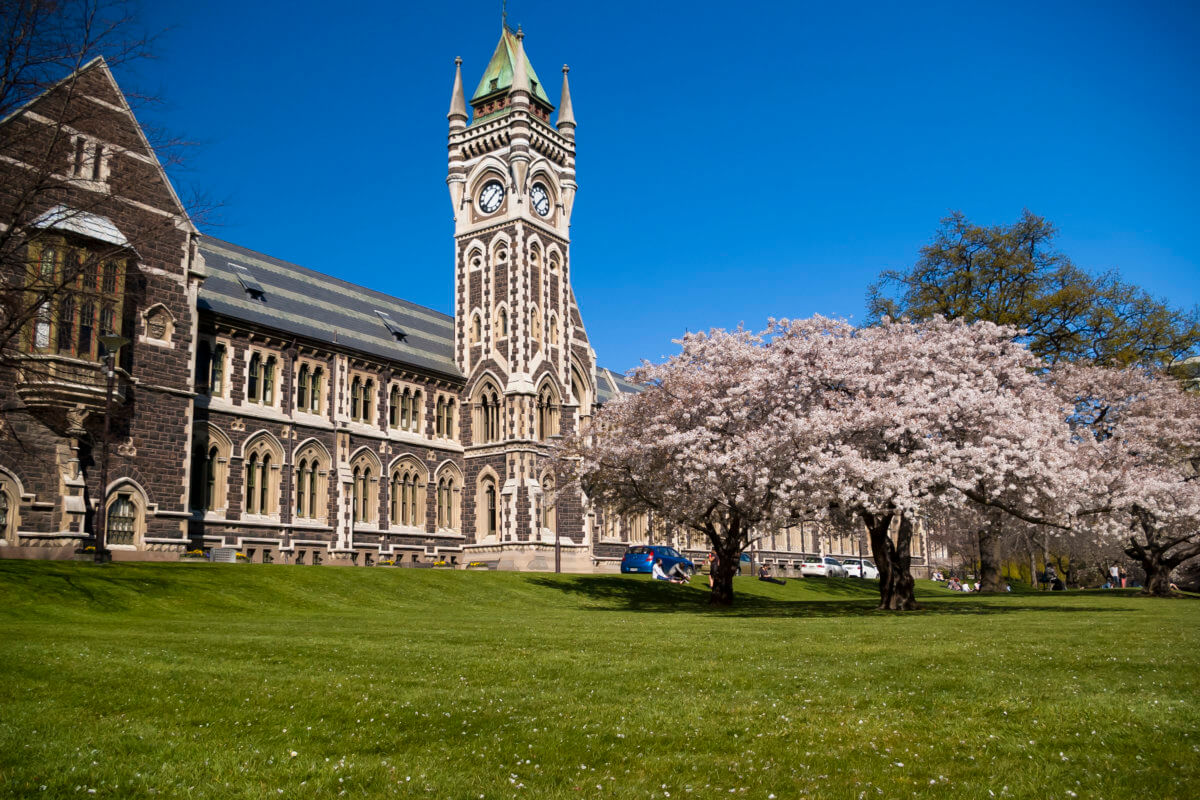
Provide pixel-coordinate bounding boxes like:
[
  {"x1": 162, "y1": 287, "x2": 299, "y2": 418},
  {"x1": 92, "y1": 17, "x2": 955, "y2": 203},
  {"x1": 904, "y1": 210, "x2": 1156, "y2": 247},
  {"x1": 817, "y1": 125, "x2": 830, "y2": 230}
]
[{"x1": 0, "y1": 561, "x2": 1200, "y2": 800}]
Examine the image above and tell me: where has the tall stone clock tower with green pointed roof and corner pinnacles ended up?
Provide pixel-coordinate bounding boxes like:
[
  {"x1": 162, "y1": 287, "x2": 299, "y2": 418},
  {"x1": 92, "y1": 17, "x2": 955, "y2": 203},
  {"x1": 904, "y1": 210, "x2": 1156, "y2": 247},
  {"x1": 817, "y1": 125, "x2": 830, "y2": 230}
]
[{"x1": 446, "y1": 25, "x2": 596, "y2": 571}]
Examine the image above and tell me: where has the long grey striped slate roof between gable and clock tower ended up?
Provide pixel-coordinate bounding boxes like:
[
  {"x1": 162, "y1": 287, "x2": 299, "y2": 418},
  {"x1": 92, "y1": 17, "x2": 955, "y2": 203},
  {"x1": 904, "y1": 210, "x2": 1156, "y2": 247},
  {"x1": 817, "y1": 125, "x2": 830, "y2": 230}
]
[{"x1": 198, "y1": 236, "x2": 463, "y2": 379}]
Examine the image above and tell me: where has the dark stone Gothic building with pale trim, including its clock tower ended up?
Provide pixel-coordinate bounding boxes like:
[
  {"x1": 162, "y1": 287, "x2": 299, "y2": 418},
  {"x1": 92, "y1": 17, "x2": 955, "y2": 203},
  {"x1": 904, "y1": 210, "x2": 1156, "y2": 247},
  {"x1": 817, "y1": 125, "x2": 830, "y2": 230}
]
[{"x1": 0, "y1": 28, "x2": 936, "y2": 571}]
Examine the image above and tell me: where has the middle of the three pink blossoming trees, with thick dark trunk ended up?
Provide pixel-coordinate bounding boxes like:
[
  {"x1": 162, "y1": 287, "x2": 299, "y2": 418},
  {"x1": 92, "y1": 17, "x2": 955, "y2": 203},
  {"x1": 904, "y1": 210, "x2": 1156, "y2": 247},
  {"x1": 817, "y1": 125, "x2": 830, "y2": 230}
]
[{"x1": 769, "y1": 318, "x2": 1073, "y2": 609}]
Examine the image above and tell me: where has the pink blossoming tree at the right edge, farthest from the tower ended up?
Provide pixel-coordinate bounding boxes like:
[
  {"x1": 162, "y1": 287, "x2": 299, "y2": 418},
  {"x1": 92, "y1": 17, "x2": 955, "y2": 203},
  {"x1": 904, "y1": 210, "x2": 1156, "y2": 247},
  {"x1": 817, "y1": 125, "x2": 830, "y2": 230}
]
[{"x1": 1054, "y1": 365, "x2": 1200, "y2": 596}]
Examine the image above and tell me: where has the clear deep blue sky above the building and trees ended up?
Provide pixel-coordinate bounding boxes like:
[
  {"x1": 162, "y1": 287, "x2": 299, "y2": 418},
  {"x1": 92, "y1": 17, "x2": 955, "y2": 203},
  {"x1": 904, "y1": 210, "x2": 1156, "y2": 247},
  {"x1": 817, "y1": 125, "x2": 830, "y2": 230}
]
[{"x1": 118, "y1": 0, "x2": 1200, "y2": 369}]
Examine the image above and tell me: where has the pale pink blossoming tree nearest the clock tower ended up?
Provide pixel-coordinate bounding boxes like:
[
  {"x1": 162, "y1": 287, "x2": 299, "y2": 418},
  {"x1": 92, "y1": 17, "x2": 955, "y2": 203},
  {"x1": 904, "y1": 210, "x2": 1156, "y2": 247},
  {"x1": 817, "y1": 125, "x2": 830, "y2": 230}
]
[{"x1": 563, "y1": 330, "x2": 792, "y2": 606}]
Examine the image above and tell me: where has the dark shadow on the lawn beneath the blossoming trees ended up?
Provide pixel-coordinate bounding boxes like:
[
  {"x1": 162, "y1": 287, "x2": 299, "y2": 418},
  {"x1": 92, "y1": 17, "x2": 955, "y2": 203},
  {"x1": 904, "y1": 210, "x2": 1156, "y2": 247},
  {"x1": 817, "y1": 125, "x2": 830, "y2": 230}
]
[{"x1": 529, "y1": 576, "x2": 1129, "y2": 619}]
